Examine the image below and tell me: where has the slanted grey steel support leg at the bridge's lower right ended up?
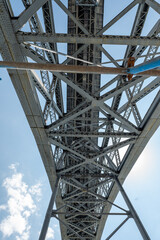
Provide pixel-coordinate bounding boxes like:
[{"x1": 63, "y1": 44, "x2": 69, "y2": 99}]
[{"x1": 115, "y1": 177, "x2": 151, "y2": 240}]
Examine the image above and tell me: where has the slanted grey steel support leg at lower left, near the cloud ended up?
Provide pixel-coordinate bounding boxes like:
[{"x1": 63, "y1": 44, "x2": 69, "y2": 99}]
[{"x1": 39, "y1": 177, "x2": 60, "y2": 240}]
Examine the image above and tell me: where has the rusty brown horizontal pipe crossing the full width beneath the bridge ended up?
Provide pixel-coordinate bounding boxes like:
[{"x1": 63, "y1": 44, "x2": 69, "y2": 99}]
[{"x1": 0, "y1": 61, "x2": 160, "y2": 76}]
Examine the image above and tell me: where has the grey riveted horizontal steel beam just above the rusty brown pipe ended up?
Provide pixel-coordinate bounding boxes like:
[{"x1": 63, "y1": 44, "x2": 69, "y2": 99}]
[{"x1": 16, "y1": 32, "x2": 160, "y2": 46}]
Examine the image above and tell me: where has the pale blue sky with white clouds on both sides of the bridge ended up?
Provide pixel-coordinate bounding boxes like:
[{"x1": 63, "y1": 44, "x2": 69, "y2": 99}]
[{"x1": 0, "y1": 0, "x2": 160, "y2": 240}]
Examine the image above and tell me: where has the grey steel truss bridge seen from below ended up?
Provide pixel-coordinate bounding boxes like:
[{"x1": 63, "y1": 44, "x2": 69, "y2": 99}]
[{"x1": 0, "y1": 0, "x2": 160, "y2": 240}]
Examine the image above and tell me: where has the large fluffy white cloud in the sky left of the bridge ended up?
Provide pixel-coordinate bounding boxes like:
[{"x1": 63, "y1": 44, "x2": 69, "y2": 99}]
[{"x1": 0, "y1": 164, "x2": 41, "y2": 240}]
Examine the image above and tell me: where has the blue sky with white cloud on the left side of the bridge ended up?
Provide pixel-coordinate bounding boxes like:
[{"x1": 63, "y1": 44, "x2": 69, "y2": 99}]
[{"x1": 0, "y1": 64, "x2": 61, "y2": 240}]
